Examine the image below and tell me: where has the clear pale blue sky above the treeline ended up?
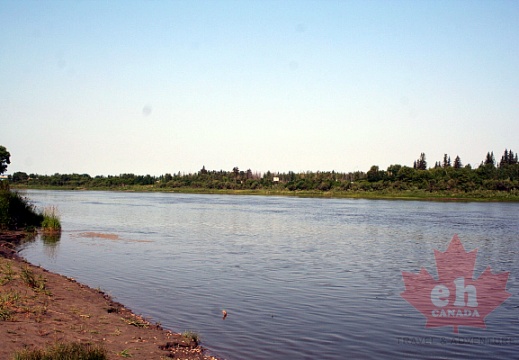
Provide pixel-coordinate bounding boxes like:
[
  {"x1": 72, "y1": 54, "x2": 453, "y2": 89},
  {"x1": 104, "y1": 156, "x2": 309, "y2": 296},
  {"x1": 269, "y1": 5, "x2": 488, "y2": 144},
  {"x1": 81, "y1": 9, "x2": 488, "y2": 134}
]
[{"x1": 0, "y1": 0, "x2": 519, "y2": 176}]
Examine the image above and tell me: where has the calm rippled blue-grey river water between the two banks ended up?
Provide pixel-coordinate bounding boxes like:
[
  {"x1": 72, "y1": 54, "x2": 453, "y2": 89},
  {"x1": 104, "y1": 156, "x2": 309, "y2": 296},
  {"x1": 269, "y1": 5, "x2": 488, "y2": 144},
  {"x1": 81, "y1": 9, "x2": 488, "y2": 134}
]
[{"x1": 21, "y1": 191, "x2": 519, "y2": 360}]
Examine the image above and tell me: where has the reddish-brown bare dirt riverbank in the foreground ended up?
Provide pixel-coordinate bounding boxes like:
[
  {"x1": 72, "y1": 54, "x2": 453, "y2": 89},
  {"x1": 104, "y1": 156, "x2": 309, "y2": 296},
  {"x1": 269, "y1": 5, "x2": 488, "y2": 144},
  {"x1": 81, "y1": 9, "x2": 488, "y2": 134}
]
[{"x1": 0, "y1": 231, "x2": 220, "y2": 360}]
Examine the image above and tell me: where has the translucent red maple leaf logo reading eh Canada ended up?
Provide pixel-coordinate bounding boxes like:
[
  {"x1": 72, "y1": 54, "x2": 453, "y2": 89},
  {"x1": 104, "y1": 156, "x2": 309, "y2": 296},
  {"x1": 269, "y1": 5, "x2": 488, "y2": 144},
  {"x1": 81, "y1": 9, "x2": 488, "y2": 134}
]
[{"x1": 400, "y1": 235, "x2": 512, "y2": 333}]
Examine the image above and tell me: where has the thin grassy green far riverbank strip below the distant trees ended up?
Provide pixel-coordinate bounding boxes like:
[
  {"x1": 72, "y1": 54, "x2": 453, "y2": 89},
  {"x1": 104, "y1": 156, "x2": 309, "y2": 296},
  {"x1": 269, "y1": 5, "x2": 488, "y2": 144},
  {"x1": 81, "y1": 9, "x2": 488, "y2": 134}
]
[{"x1": 11, "y1": 184, "x2": 519, "y2": 202}]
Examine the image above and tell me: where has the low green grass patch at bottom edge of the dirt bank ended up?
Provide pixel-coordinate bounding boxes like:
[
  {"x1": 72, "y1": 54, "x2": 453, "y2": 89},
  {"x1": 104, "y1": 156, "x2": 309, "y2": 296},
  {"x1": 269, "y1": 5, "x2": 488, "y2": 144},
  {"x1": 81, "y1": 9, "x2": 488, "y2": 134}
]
[{"x1": 13, "y1": 343, "x2": 108, "y2": 360}]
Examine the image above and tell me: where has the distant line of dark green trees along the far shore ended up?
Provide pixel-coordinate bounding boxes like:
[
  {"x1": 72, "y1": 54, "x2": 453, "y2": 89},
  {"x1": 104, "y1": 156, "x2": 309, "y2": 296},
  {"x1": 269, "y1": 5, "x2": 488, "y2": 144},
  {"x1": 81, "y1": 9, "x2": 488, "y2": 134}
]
[{"x1": 9, "y1": 150, "x2": 519, "y2": 194}]
